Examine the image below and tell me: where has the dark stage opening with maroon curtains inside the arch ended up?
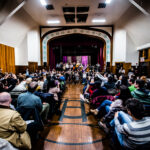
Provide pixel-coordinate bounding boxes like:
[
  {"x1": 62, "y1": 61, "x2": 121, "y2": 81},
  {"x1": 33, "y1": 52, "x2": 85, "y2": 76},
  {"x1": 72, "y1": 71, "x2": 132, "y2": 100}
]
[{"x1": 49, "y1": 34, "x2": 104, "y2": 69}]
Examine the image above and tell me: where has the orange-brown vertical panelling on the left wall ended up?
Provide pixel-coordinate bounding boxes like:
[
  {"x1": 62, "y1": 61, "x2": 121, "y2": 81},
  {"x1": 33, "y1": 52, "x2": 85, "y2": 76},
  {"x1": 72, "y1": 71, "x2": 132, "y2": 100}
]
[{"x1": 0, "y1": 44, "x2": 15, "y2": 73}]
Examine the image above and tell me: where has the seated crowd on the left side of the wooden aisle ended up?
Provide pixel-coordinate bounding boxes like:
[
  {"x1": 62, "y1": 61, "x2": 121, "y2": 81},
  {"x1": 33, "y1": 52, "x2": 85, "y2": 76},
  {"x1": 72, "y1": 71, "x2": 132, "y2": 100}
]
[{"x1": 0, "y1": 69, "x2": 66, "y2": 150}]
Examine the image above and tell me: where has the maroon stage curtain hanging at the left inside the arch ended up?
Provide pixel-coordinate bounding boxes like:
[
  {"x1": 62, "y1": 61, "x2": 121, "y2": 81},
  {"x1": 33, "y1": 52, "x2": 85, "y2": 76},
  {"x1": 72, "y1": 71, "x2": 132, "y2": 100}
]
[{"x1": 49, "y1": 47, "x2": 56, "y2": 70}]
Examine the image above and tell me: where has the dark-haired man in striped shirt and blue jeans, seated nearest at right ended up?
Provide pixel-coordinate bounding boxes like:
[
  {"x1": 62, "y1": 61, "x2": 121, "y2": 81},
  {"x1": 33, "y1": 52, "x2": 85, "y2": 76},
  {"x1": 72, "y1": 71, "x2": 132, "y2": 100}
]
[{"x1": 114, "y1": 99, "x2": 150, "y2": 149}]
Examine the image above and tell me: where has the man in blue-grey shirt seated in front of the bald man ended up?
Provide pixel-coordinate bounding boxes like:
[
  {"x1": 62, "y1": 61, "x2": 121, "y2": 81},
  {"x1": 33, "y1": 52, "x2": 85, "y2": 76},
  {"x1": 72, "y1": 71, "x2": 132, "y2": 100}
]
[{"x1": 17, "y1": 82, "x2": 49, "y2": 121}]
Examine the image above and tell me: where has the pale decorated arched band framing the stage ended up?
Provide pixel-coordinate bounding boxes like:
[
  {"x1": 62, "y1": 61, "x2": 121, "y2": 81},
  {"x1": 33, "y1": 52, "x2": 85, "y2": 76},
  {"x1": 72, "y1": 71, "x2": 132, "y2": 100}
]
[{"x1": 42, "y1": 29, "x2": 111, "y2": 63}]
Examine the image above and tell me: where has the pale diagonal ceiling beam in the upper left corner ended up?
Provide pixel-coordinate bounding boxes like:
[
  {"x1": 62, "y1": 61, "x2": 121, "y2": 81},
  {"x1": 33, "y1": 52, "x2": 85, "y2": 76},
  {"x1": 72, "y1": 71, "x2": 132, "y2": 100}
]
[{"x1": 0, "y1": 0, "x2": 27, "y2": 25}]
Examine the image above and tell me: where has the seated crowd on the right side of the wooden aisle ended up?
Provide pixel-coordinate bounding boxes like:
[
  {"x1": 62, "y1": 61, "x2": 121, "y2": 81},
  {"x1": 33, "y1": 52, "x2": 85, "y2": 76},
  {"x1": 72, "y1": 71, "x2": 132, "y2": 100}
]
[{"x1": 80, "y1": 67, "x2": 150, "y2": 150}]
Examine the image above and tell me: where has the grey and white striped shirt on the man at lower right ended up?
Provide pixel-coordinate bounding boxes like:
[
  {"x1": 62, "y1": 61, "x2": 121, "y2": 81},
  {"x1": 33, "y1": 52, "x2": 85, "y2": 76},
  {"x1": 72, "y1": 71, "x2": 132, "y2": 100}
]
[{"x1": 115, "y1": 117, "x2": 150, "y2": 149}]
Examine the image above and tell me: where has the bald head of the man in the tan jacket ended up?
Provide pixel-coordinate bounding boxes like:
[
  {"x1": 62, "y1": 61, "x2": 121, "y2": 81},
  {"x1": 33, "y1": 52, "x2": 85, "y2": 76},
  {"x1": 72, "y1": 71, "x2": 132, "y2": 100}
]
[{"x1": 0, "y1": 92, "x2": 11, "y2": 106}]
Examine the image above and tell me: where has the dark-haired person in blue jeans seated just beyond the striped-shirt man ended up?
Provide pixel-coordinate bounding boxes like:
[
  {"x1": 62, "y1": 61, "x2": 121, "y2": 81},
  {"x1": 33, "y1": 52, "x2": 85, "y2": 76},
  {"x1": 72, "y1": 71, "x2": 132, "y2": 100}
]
[{"x1": 90, "y1": 85, "x2": 132, "y2": 127}]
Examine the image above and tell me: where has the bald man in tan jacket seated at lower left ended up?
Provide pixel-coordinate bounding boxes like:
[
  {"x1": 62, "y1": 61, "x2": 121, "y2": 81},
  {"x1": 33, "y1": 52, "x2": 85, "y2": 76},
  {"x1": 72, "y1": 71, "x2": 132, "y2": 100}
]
[{"x1": 0, "y1": 92, "x2": 31, "y2": 149}]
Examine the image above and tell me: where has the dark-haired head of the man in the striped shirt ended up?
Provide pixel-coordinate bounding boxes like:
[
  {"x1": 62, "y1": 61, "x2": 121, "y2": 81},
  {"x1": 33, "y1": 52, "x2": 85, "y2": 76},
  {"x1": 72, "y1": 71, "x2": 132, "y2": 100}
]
[{"x1": 126, "y1": 98, "x2": 145, "y2": 119}]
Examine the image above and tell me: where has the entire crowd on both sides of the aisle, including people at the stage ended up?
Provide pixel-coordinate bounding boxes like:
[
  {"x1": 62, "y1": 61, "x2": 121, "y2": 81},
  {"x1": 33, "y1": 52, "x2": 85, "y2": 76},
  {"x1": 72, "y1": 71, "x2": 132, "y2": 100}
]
[{"x1": 0, "y1": 62, "x2": 150, "y2": 150}]
